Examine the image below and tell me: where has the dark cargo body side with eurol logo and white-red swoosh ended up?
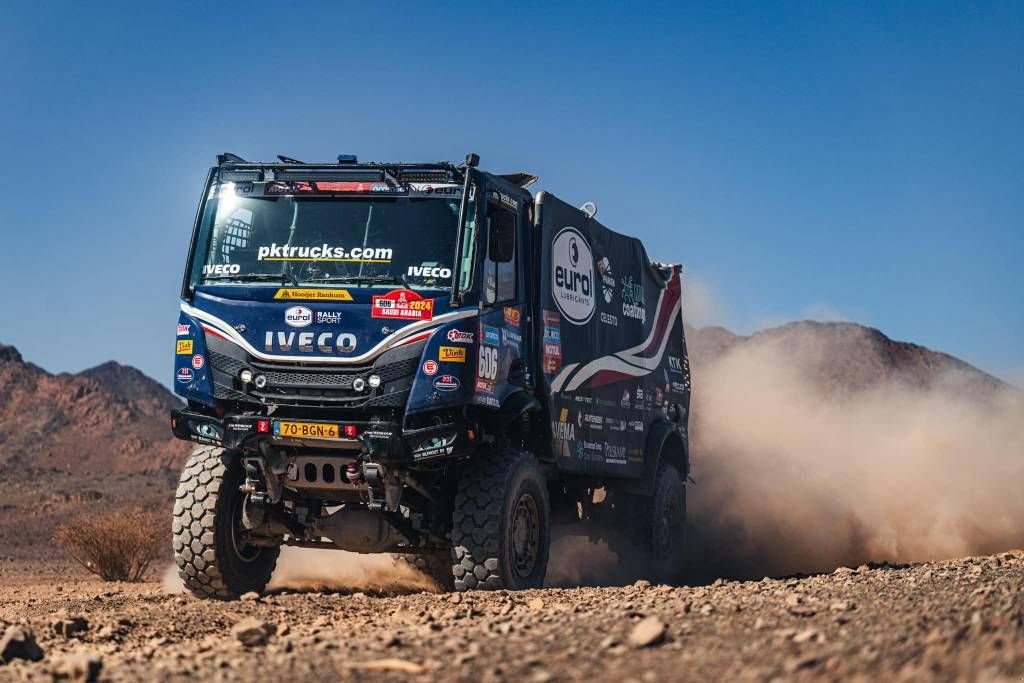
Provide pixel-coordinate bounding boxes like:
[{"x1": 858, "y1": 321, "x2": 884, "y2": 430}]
[{"x1": 537, "y1": 193, "x2": 690, "y2": 477}]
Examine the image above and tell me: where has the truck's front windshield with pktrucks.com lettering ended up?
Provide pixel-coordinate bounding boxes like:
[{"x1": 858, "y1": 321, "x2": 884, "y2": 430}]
[{"x1": 193, "y1": 183, "x2": 461, "y2": 289}]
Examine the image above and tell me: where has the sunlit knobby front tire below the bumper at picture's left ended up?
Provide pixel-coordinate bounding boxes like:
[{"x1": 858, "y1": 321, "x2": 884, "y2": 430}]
[{"x1": 171, "y1": 446, "x2": 281, "y2": 600}]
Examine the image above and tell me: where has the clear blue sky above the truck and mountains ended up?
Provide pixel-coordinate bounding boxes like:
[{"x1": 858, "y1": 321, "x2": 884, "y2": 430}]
[{"x1": 0, "y1": 2, "x2": 1024, "y2": 384}]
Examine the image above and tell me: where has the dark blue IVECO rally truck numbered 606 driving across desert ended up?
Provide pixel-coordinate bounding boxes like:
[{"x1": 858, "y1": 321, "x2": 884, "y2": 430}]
[{"x1": 170, "y1": 154, "x2": 690, "y2": 599}]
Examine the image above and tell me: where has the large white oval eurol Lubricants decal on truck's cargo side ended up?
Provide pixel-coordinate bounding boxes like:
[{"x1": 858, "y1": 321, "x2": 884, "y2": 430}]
[{"x1": 551, "y1": 227, "x2": 594, "y2": 325}]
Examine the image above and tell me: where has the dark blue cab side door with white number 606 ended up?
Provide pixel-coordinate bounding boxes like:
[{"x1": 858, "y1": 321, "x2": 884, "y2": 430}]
[{"x1": 472, "y1": 187, "x2": 529, "y2": 408}]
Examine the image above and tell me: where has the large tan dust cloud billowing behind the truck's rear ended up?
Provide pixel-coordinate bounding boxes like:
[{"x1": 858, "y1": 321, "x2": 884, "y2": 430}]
[{"x1": 688, "y1": 331, "x2": 1024, "y2": 580}]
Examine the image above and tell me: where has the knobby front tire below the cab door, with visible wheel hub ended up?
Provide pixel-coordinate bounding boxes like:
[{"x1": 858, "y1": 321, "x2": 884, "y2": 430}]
[{"x1": 452, "y1": 449, "x2": 551, "y2": 592}]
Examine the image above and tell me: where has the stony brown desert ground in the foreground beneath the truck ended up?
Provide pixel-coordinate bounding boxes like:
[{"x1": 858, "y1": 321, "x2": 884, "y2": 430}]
[{"x1": 0, "y1": 551, "x2": 1024, "y2": 681}]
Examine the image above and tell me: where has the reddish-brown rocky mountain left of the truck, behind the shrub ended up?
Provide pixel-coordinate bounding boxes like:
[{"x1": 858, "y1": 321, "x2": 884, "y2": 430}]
[{"x1": 0, "y1": 345, "x2": 191, "y2": 473}]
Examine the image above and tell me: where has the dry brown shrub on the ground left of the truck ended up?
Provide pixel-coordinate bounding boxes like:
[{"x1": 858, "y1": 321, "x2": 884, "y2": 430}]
[{"x1": 53, "y1": 508, "x2": 169, "y2": 582}]
